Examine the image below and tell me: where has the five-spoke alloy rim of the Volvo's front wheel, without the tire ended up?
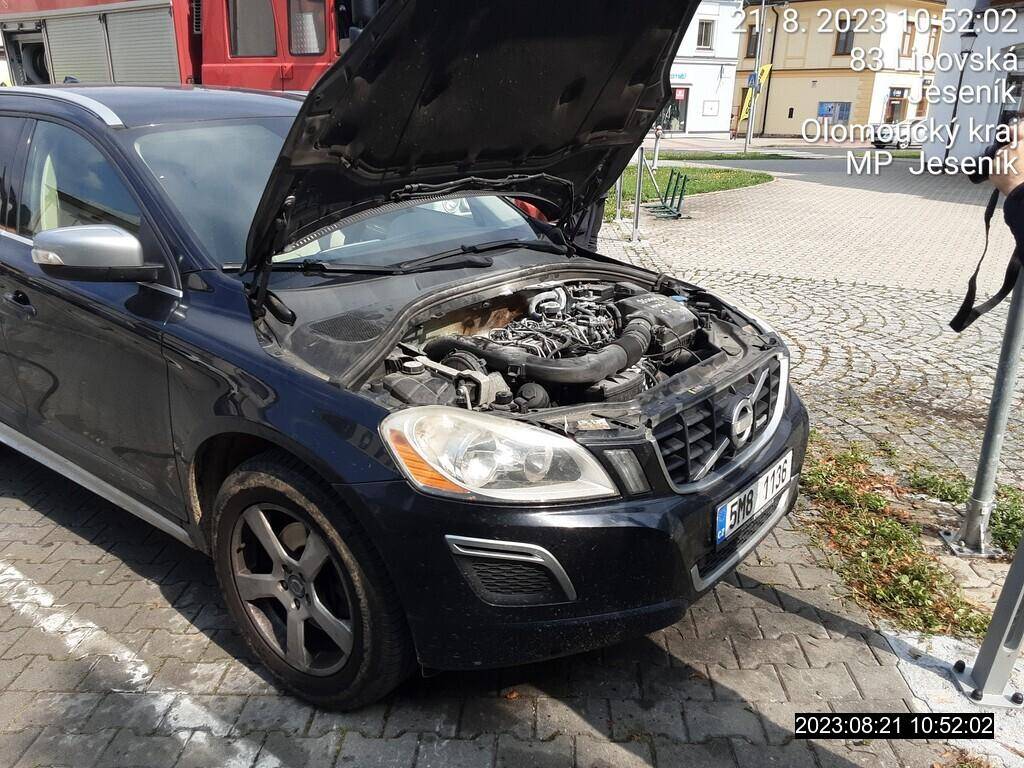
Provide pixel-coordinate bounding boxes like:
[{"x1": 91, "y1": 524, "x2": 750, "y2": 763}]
[{"x1": 231, "y1": 504, "x2": 355, "y2": 676}]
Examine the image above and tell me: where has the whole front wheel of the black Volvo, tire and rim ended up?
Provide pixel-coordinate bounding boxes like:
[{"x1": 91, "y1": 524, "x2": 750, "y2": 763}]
[{"x1": 212, "y1": 453, "x2": 414, "y2": 709}]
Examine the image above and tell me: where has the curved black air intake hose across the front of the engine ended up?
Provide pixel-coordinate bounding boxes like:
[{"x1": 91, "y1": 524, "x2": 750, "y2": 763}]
[{"x1": 423, "y1": 318, "x2": 651, "y2": 384}]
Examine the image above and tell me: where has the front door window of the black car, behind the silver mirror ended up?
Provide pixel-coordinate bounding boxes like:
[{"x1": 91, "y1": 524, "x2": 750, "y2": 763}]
[{"x1": 18, "y1": 121, "x2": 142, "y2": 237}]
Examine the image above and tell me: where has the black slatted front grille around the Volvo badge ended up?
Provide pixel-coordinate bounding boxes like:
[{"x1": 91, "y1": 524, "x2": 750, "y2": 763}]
[{"x1": 654, "y1": 357, "x2": 782, "y2": 485}]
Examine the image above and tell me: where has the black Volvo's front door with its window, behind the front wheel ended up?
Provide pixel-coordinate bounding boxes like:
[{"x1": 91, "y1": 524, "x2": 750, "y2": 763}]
[{"x1": 0, "y1": 120, "x2": 184, "y2": 517}]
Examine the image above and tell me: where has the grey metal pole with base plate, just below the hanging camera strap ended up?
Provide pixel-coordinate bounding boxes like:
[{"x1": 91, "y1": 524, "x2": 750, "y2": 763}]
[{"x1": 942, "y1": 270, "x2": 1024, "y2": 567}]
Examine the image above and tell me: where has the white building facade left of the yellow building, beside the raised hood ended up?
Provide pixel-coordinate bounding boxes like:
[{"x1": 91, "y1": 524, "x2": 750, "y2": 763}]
[{"x1": 658, "y1": 0, "x2": 743, "y2": 136}]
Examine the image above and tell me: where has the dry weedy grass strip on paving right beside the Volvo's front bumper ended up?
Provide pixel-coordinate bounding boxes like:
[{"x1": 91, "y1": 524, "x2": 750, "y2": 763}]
[{"x1": 802, "y1": 442, "x2": 989, "y2": 637}]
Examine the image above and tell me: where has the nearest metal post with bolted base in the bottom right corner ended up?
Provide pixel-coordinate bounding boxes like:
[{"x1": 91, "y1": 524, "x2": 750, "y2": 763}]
[{"x1": 953, "y1": 524, "x2": 1024, "y2": 709}]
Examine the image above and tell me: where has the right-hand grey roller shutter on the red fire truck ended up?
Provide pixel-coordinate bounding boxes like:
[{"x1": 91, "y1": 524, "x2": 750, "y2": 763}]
[{"x1": 106, "y1": 8, "x2": 181, "y2": 84}]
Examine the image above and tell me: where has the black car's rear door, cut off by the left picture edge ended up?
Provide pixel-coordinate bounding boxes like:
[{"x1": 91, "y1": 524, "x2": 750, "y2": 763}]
[{"x1": 0, "y1": 115, "x2": 29, "y2": 430}]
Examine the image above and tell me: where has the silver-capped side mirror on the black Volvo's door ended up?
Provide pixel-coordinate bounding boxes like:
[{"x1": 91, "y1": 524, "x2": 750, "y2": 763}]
[{"x1": 32, "y1": 224, "x2": 160, "y2": 283}]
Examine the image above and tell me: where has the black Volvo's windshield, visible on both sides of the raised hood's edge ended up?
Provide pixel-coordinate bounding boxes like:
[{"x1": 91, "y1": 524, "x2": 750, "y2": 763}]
[{"x1": 132, "y1": 118, "x2": 539, "y2": 266}]
